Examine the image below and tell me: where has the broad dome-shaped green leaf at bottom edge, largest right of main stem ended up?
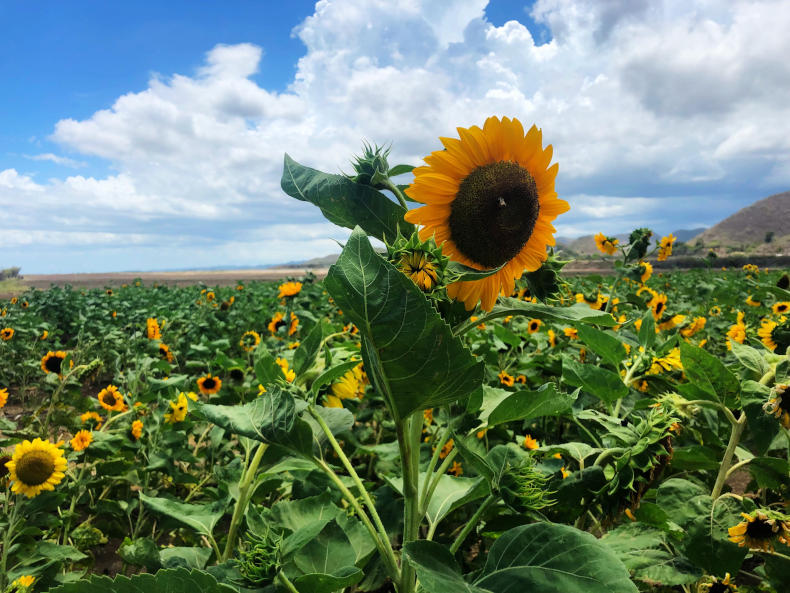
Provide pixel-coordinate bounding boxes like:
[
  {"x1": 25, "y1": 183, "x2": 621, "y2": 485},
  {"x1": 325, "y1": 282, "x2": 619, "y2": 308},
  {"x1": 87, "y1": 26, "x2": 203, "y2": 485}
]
[{"x1": 475, "y1": 523, "x2": 637, "y2": 593}]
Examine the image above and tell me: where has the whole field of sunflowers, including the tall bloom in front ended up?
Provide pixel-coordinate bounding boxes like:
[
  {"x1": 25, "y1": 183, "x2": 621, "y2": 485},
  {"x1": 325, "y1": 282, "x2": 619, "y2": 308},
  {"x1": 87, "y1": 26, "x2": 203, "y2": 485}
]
[{"x1": 0, "y1": 118, "x2": 790, "y2": 593}]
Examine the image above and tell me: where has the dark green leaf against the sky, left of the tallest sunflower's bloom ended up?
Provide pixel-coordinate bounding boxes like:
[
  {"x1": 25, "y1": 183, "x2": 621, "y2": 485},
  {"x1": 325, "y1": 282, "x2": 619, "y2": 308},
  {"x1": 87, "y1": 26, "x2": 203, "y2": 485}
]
[{"x1": 280, "y1": 154, "x2": 414, "y2": 242}]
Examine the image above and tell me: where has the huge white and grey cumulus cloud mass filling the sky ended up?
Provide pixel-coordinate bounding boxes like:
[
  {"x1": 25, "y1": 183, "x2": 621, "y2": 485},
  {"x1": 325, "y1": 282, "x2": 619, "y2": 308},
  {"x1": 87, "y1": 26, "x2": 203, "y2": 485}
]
[{"x1": 0, "y1": 0, "x2": 790, "y2": 271}]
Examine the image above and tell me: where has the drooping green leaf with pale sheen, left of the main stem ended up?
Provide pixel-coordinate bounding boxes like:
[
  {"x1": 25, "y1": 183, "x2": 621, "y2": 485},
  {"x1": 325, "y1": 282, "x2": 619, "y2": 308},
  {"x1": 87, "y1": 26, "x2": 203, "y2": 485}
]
[{"x1": 194, "y1": 386, "x2": 313, "y2": 456}]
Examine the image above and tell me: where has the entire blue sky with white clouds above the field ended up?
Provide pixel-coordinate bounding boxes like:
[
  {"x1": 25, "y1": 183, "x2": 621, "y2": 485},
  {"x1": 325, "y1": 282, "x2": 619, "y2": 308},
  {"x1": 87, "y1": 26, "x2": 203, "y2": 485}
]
[{"x1": 0, "y1": 0, "x2": 790, "y2": 273}]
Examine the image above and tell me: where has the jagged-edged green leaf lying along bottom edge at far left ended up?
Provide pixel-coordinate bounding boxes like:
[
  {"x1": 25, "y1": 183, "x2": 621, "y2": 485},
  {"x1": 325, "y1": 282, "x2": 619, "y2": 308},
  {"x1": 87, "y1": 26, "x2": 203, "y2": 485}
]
[{"x1": 50, "y1": 568, "x2": 237, "y2": 593}]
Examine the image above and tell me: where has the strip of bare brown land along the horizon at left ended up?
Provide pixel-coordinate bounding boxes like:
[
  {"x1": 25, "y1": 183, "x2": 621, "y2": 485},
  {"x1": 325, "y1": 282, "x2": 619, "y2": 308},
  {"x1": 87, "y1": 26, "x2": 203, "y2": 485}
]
[{"x1": 0, "y1": 268, "x2": 327, "y2": 298}]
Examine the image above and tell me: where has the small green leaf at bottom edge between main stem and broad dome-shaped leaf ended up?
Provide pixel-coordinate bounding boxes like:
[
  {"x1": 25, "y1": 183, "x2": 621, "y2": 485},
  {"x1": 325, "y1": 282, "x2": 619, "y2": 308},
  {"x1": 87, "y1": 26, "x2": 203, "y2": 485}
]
[{"x1": 403, "y1": 540, "x2": 490, "y2": 593}]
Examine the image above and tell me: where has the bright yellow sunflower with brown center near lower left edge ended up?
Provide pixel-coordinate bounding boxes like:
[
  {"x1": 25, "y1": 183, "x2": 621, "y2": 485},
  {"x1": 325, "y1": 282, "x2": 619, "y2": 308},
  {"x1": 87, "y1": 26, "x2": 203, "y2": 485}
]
[{"x1": 5, "y1": 438, "x2": 67, "y2": 498}]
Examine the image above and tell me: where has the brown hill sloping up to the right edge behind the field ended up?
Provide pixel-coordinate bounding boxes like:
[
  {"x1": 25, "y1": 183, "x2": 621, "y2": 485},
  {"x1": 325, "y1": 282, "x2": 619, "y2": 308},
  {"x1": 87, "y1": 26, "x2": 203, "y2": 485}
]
[{"x1": 688, "y1": 191, "x2": 790, "y2": 254}]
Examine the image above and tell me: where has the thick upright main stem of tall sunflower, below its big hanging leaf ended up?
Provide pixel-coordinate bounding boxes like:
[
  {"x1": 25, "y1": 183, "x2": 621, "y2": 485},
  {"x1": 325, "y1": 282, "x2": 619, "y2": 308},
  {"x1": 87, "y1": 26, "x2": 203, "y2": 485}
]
[{"x1": 395, "y1": 414, "x2": 422, "y2": 593}]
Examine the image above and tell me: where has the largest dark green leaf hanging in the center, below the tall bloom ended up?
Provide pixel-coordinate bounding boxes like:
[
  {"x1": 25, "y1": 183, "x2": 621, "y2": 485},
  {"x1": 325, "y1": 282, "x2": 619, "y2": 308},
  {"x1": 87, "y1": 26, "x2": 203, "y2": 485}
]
[{"x1": 324, "y1": 228, "x2": 483, "y2": 417}]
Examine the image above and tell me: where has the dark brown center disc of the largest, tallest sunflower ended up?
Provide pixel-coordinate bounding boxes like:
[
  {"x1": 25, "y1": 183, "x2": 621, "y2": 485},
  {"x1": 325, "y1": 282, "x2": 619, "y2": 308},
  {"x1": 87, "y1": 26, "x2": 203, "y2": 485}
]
[{"x1": 448, "y1": 161, "x2": 540, "y2": 268}]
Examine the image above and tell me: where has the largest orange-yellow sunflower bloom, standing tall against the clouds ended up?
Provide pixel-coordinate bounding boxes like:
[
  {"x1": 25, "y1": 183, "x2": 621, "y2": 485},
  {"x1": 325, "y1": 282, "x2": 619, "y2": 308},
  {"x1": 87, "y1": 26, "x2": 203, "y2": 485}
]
[{"x1": 405, "y1": 117, "x2": 569, "y2": 310}]
